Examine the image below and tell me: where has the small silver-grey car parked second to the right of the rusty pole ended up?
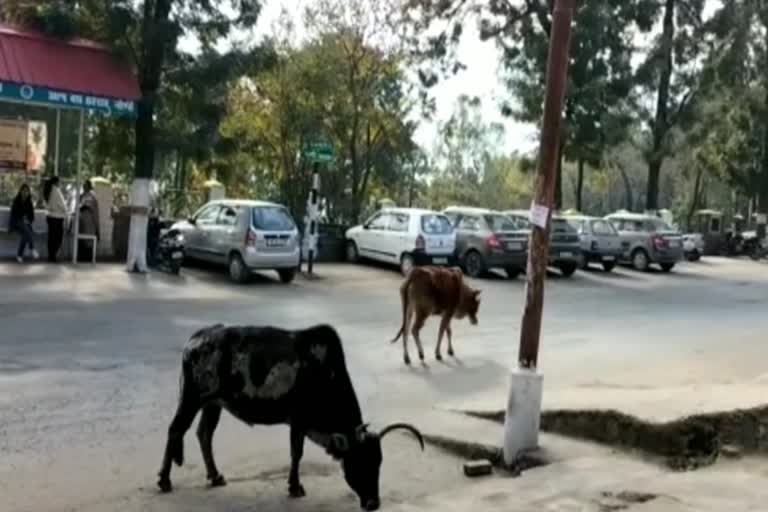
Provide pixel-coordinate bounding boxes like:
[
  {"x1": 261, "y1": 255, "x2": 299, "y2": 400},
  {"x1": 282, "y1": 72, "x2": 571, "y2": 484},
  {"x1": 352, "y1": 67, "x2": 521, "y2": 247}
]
[{"x1": 564, "y1": 215, "x2": 622, "y2": 272}]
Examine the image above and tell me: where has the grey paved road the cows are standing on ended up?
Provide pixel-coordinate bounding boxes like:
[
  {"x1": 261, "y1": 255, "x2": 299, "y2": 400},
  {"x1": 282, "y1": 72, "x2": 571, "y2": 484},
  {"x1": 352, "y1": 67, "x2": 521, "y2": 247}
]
[{"x1": 0, "y1": 259, "x2": 768, "y2": 512}]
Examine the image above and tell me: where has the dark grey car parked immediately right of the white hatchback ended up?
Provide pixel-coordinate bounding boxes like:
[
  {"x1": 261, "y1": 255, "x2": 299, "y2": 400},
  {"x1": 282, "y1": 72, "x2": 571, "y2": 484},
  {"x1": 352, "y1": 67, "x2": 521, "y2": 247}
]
[{"x1": 443, "y1": 206, "x2": 530, "y2": 279}]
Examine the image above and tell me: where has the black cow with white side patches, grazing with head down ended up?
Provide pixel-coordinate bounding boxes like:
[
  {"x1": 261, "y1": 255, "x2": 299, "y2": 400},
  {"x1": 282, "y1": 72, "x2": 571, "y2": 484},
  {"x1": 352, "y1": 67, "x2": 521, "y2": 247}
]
[{"x1": 158, "y1": 324, "x2": 424, "y2": 510}]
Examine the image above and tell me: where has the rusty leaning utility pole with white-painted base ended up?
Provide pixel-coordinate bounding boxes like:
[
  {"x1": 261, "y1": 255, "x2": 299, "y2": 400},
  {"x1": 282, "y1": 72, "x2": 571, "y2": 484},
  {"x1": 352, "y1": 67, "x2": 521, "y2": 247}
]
[{"x1": 504, "y1": 0, "x2": 575, "y2": 465}]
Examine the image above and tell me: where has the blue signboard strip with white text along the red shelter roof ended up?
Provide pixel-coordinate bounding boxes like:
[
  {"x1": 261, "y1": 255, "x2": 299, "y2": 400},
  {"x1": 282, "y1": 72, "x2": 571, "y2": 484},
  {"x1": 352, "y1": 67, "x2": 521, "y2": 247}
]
[{"x1": 0, "y1": 82, "x2": 136, "y2": 117}]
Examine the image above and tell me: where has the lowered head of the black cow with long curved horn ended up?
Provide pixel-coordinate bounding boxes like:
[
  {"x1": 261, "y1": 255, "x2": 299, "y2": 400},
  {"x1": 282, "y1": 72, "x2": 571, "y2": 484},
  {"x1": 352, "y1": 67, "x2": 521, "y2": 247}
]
[{"x1": 333, "y1": 423, "x2": 424, "y2": 511}]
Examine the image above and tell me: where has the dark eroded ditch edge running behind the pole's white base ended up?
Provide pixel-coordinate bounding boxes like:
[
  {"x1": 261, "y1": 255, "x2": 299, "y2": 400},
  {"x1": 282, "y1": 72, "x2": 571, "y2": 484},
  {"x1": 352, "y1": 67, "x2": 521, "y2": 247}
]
[{"x1": 465, "y1": 406, "x2": 768, "y2": 470}]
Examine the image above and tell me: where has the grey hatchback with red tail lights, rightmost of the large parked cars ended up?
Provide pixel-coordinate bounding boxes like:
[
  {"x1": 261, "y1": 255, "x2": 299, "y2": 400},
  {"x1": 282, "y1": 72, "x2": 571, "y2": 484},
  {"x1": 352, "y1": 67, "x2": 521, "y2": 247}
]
[{"x1": 606, "y1": 212, "x2": 683, "y2": 272}]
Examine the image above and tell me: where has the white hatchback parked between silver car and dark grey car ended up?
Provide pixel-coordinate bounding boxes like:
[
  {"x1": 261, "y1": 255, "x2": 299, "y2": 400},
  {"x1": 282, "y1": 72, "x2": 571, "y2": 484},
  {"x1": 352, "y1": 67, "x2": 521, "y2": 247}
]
[{"x1": 346, "y1": 208, "x2": 456, "y2": 275}]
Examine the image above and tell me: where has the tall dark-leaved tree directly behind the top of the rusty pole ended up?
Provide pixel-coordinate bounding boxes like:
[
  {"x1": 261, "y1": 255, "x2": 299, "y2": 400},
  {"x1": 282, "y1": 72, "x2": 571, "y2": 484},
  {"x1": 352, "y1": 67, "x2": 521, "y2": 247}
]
[{"x1": 402, "y1": 0, "x2": 653, "y2": 207}]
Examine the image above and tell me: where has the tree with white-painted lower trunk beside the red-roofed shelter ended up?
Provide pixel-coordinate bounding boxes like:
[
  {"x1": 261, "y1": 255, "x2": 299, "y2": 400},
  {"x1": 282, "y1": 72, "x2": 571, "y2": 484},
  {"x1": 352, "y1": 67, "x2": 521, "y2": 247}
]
[{"x1": 3, "y1": 0, "x2": 270, "y2": 272}]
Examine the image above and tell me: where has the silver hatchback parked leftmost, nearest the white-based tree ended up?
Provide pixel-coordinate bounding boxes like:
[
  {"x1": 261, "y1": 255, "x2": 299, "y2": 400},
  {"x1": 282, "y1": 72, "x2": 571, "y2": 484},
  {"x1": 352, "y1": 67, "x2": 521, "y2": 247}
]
[{"x1": 172, "y1": 199, "x2": 300, "y2": 283}]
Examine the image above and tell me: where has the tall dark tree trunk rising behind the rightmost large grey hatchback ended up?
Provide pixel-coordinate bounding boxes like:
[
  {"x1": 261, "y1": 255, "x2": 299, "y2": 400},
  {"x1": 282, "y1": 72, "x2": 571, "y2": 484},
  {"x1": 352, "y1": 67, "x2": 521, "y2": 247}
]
[{"x1": 645, "y1": 0, "x2": 676, "y2": 211}]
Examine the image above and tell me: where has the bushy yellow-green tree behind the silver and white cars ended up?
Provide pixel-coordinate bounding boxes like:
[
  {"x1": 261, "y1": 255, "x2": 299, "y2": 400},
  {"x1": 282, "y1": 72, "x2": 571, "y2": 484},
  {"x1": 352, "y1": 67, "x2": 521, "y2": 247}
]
[{"x1": 222, "y1": 2, "x2": 416, "y2": 222}]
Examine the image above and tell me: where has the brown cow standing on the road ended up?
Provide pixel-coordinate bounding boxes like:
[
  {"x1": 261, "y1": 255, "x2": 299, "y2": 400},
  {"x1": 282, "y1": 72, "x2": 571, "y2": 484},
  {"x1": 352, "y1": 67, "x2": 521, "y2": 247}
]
[{"x1": 392, "y1": 267, "x2": 481, "y2": 365}]
